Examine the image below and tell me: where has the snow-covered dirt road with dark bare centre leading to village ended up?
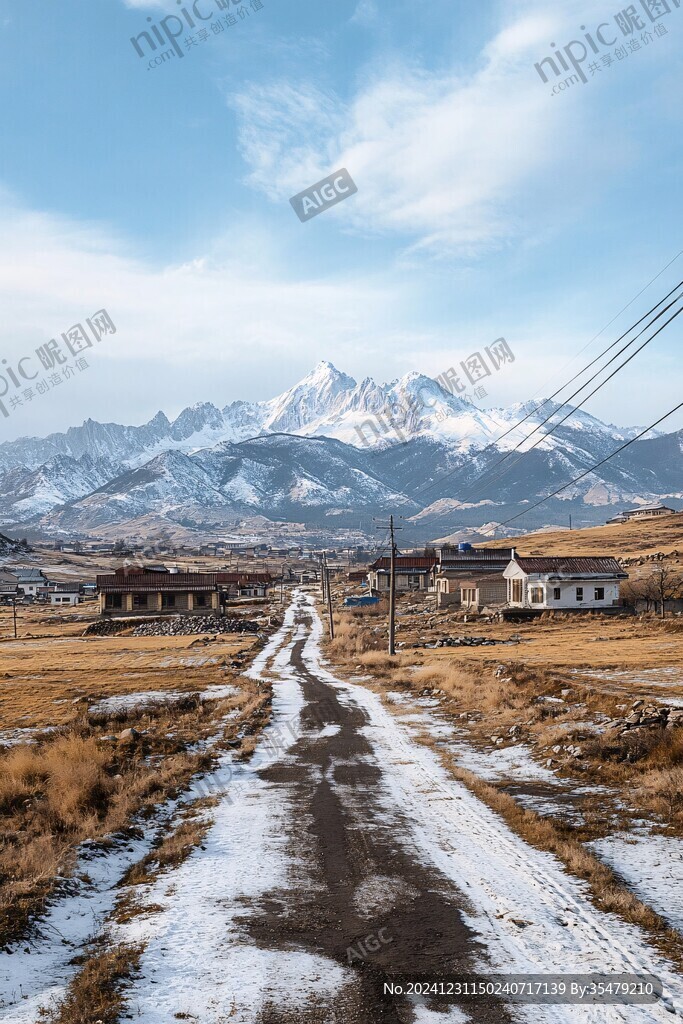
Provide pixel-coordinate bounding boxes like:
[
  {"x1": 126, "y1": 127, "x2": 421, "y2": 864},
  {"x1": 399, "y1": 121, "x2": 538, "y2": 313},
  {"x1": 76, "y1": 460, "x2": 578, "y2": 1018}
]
[{"x1": 0, "y1": 593, "x2": 681, "y2": 1024}]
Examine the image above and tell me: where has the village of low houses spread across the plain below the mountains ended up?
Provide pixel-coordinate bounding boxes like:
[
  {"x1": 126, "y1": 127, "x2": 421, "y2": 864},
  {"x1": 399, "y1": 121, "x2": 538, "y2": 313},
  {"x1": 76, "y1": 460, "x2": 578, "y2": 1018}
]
[{"x1": 0, "y1": 504, "x2": 683, "y2": 618}]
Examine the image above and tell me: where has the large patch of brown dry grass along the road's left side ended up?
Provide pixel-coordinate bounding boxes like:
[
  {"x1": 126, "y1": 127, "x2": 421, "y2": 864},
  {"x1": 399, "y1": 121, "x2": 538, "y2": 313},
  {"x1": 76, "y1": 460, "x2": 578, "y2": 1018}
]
[{"x1": 0, "y1": 679, "x2": 269, "y2": 948}]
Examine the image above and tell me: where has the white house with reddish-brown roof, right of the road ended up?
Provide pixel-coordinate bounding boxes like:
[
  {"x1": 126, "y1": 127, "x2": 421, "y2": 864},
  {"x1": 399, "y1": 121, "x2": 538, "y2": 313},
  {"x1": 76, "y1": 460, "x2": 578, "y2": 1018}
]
[{"x1": 503, "y1": 555, "x2": 629, "y2": 611}]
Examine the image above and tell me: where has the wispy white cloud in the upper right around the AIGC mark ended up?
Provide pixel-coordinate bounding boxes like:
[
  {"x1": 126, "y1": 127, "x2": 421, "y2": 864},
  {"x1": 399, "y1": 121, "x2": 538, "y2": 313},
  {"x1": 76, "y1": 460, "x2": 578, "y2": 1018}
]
[{"x1": 228, "y1": 3, "x2": 630, "y2": 255}]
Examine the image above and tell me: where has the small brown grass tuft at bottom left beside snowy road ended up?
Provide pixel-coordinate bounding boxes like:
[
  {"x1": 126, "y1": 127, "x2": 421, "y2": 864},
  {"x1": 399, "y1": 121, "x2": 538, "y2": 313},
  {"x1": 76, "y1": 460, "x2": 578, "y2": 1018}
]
[{"x1": 41, "y1": 939, "x2": 143, "y2": 1024}]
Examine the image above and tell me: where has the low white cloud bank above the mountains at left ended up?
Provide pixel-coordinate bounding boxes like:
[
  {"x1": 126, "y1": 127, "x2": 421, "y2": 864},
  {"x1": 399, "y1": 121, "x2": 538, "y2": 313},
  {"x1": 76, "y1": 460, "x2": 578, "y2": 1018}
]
[{"x1": 0, "y1": 195, "x2": 428, "y2": 438}]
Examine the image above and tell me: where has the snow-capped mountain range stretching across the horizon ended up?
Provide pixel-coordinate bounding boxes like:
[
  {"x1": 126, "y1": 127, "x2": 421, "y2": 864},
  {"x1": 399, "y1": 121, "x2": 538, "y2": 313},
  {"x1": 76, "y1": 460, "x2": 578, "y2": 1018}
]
[{"x1": 0, "y1": 362, "x2": 683, "y2": 541}]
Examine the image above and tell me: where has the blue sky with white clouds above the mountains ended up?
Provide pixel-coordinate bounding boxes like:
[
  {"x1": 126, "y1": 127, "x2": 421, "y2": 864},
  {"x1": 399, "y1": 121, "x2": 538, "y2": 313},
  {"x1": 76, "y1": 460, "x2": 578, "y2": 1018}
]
[{"x1": 0, "y1": 0, "x2": 683, "y2": 440}]
